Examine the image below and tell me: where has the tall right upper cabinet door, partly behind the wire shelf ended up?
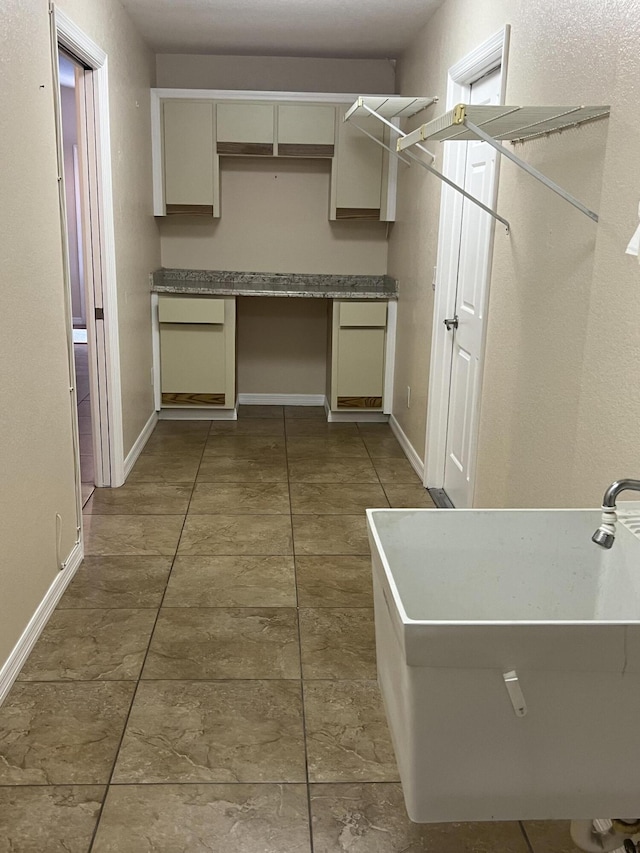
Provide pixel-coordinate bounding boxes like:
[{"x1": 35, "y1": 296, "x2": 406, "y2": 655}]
[{"x1": 330, "y1": 109, "x2": 384, "y2": 220}]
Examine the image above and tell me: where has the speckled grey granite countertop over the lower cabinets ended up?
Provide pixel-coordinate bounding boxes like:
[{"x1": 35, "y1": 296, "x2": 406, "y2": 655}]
[{"x1": 151, "y1": 269, "x2": 398, "y2": 299}]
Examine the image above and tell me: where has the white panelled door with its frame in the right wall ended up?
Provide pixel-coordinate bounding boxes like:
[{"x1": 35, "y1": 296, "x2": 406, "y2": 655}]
[{"x1": 424, "y1": 26, "x2": 509, "y2": 508}]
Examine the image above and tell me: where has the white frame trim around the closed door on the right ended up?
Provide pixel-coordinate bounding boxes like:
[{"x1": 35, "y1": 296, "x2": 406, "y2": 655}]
[{"x1": 424, "y1": 24, "x2": 511, "y2": 500}]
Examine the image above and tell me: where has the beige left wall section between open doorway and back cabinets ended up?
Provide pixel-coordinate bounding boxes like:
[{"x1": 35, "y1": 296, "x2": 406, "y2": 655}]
[{"x1": 59, "y1": 0, "x2": 160, "y2": 455}]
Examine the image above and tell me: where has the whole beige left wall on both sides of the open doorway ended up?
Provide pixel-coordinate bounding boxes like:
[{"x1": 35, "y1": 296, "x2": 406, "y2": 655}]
[{"x1": 0, "y1": 0, "x2": 159, "y2": 665}]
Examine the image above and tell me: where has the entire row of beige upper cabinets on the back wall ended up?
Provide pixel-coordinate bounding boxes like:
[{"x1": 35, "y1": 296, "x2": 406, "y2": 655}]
[{"x1": 152, "y1": 90, "x2": 397, "y2": 221}]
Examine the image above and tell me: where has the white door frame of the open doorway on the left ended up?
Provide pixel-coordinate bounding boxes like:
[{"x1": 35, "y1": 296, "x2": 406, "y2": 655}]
[{"x1": 49, "y1": 8, "x2": 125, "y2": 489}]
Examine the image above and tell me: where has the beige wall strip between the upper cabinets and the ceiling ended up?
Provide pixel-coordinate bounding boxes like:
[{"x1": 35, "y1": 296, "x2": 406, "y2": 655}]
[{"x1": 156, "y1": 53, "x2": 395, "y2": 94}]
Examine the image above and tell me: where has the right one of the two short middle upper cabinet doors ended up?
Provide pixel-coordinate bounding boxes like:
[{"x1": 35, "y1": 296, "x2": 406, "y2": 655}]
[{"x1": 278, "y1": 104, "x2": 336, "y2": 157}]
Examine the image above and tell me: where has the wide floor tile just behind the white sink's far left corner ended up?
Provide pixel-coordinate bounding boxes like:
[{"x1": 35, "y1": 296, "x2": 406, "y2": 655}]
[{"x1": 290, "y1": 483, "x2": 389, "y2": 515}]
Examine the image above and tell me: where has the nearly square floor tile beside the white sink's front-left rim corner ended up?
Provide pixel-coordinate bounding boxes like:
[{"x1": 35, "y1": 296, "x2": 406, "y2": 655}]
[{"x1": 299, "y1": 607, "x2": 376, "y2": 680}]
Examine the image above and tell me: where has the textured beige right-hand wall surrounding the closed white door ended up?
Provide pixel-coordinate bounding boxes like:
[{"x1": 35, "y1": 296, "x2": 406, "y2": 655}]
[{"x1": 389, "y1": 0, "x2": 640, "y2": 506}]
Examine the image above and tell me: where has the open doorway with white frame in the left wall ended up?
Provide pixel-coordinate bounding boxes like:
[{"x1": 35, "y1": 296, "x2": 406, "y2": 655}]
[{"x1": 50, "y1": 5, "x2": 124, "y2": 512}]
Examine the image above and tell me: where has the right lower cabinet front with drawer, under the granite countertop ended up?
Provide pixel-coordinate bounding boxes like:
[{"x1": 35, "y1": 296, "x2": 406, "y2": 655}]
[{"x1": 331, "y1": 301, "x2": 387, "y2": 411}]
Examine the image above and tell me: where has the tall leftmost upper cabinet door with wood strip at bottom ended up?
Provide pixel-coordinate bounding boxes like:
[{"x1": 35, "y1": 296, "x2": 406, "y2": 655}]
[{"x1": 163, "y1": 100, "x2": 215, "y2": 216}]
